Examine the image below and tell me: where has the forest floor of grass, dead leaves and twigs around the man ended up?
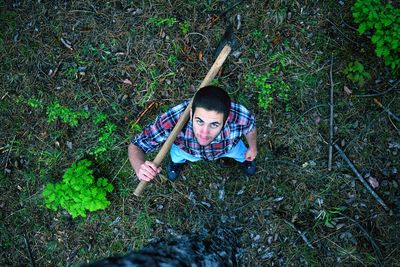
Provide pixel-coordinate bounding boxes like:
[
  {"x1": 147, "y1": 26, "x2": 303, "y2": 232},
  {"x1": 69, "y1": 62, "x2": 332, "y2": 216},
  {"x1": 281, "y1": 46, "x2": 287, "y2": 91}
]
[{"x1": 0, "y1": 0, "x2": 400, "y2": 266}]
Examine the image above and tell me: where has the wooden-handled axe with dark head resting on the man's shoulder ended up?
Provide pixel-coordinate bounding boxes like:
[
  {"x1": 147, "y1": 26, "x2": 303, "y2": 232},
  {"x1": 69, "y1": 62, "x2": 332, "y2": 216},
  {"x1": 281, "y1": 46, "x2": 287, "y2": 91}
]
[{"x1": 133, "y1": 24, "x2": 237, "y2": 196}]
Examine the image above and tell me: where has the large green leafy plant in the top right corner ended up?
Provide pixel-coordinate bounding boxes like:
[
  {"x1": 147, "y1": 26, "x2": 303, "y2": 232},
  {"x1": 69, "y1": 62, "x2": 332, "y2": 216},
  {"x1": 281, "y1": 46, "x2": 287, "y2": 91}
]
[{"x1": 352, "y1": 0, "x2": 400, "y2": 71}]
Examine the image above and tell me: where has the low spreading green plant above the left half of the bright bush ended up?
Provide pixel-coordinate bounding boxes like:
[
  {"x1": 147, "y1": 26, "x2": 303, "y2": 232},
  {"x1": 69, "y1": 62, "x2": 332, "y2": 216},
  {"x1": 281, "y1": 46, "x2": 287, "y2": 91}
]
[{"x1": 47, "y1": 102, "x2": 89, "y2": 126}]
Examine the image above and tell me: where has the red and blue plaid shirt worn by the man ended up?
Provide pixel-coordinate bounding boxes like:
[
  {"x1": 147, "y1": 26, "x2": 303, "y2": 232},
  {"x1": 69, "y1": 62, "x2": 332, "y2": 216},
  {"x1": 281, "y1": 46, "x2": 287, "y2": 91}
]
[{"x1": 131, "y1": 100, "x2": 256, "y2": 160}]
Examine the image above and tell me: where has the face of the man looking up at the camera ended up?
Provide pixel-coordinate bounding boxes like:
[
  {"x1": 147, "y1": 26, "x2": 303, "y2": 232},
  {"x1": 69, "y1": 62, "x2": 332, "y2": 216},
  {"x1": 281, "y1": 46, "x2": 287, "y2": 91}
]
[{"x1": 190, "y1": 107, "x2": 224, "y2": 146}]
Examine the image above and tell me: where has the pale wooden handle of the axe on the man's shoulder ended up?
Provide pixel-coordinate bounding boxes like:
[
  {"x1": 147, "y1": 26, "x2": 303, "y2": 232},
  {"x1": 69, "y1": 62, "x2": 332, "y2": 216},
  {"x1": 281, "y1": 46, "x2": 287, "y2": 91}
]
[{"x1": 133, "y1": 45, "x2": 232, "y2": 196}]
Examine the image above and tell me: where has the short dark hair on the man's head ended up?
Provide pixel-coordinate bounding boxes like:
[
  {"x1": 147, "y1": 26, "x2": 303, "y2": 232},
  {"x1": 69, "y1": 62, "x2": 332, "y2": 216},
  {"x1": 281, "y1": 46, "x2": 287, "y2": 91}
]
[{"x1": 192, "y1": 85, "x2": 231, "y2": 123}]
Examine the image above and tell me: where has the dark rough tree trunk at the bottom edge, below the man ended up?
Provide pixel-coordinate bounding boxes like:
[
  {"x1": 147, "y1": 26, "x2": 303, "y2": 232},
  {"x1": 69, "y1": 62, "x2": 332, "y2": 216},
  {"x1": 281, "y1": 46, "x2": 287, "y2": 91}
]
[{"x1": 83, "y1": 229, "x2": 241, "y2": 267}]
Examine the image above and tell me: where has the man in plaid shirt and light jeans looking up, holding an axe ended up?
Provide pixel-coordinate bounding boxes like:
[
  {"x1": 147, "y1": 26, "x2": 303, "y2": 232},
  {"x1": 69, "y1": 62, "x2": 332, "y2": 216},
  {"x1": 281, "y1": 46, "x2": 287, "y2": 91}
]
[{"x1": 128, "y1": 86, "x2": 257, "y2": 181}]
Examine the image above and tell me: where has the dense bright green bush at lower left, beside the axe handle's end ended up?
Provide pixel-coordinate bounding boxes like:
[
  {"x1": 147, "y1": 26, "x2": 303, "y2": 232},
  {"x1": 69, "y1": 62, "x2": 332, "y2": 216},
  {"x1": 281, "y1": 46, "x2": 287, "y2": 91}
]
[{"x1": 42, "y1": 160, "x2": 114, "y2": 218}]
